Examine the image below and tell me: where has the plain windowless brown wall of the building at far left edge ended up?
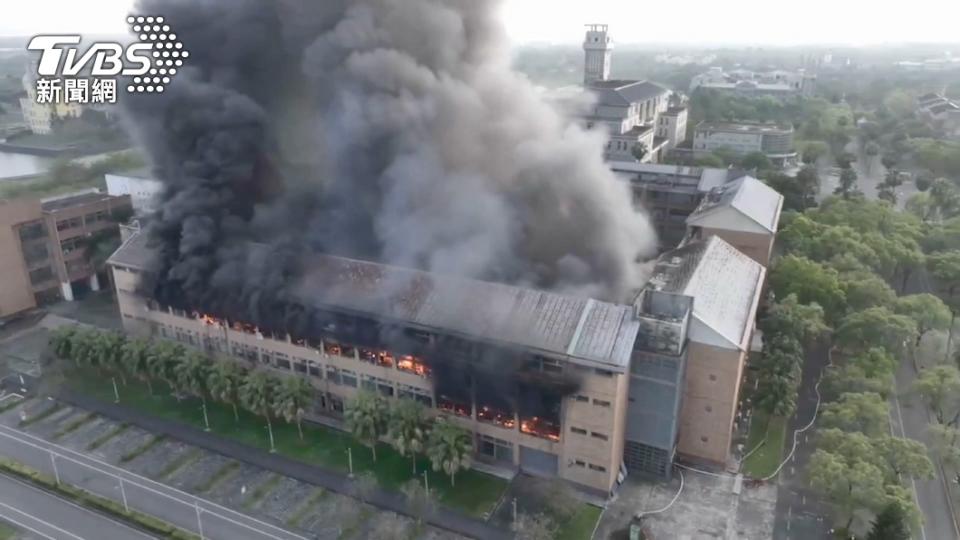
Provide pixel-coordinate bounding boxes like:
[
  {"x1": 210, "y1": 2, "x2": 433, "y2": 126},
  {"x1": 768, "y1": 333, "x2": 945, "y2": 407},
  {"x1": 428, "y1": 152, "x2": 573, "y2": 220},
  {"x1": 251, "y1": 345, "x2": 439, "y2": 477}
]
[{"x1": 0, "y1": 201, "x2": 42, "y2": 318}]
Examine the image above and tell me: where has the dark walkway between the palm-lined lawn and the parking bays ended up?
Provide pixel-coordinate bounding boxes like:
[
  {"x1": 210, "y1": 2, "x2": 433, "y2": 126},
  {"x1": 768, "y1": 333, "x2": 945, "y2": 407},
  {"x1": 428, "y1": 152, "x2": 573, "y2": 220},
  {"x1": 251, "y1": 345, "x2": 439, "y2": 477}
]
[{"x1": 58, "y1": 390, "x2": 511, "y2": 540}]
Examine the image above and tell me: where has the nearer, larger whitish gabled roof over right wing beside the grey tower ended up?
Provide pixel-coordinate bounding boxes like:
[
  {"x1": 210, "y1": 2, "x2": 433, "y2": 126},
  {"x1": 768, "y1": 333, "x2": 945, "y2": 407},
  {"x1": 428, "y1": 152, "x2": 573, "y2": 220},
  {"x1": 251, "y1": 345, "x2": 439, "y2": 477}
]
[{"x1": 647, "y1": 236, "x2": 766, "y2": 350}]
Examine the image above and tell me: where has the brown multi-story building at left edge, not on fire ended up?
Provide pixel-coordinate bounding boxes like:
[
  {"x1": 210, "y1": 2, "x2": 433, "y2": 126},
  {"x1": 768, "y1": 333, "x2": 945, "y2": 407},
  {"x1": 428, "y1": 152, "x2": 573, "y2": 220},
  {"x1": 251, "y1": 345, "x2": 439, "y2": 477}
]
[{"x1": 0, "y1": 190, "x2": 130, "y2": 317}]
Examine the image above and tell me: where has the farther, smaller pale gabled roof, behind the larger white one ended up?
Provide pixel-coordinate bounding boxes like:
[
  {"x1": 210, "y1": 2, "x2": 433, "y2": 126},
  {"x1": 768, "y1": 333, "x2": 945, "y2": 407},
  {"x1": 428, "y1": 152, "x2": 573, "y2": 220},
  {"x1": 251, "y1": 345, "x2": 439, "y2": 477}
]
[{"x1": 687, "y1": 176, "x2": 783, "y2": 233}]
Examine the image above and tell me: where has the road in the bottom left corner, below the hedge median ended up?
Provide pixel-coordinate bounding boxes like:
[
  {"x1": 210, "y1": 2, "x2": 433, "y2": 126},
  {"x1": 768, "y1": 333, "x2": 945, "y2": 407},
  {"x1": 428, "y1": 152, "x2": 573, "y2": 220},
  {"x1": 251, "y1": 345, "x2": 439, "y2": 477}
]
[{"x1": 0, "y1": 475, "x2": 154, "y2": 540}]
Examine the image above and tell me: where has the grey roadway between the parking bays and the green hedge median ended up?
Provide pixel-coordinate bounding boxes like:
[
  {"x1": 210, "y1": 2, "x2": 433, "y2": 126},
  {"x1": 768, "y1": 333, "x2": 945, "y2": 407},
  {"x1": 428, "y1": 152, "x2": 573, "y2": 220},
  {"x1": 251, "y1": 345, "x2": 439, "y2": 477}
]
[{"x1": 0, "y1": 425, "x2": 307, "y2": 540}]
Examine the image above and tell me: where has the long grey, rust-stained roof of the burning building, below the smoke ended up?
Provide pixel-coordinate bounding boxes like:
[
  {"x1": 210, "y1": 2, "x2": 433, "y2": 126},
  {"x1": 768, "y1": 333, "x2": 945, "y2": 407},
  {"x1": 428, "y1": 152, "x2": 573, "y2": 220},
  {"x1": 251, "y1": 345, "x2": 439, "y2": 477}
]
[{"x1": 108, "y1": 233, "x2": 640, "y2": 370}]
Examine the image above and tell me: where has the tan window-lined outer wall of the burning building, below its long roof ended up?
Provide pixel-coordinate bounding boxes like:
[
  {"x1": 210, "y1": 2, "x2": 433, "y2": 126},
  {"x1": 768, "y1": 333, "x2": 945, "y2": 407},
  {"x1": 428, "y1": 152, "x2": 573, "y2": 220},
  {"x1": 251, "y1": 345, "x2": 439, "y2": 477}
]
[{"x1": 113, "y1": 266, "x2": 628, "y2": 495}]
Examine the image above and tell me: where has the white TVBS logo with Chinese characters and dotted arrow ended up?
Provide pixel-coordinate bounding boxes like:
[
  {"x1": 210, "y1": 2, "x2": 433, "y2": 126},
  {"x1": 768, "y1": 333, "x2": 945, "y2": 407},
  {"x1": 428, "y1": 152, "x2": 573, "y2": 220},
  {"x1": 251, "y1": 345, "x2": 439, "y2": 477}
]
[{"x1": 27, "y1": 15, "x2": 190, "y2": 104}]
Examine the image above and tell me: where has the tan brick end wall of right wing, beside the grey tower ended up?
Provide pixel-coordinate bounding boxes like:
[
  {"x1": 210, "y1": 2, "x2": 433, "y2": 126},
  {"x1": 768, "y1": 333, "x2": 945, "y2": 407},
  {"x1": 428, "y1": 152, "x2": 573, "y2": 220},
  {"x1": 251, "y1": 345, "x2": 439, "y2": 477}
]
[{"x1": 677, "y1": 341, "x2": 746, "y2": 464}]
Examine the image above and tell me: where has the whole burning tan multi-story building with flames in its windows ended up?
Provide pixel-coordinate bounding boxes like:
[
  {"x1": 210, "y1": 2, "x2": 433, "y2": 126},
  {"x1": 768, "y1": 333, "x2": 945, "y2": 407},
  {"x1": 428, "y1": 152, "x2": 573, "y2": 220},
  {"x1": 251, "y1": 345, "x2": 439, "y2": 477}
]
[{"x1": 109, "y1": 217, "x2": 765, "y2": 494}]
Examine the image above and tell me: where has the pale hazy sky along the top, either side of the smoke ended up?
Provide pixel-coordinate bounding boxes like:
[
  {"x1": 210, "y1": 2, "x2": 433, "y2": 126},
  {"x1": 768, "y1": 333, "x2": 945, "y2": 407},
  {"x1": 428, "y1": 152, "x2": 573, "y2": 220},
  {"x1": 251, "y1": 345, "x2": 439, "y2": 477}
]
[{"x1": 0, "y1": 0, "x2": 960, "y2": 45}]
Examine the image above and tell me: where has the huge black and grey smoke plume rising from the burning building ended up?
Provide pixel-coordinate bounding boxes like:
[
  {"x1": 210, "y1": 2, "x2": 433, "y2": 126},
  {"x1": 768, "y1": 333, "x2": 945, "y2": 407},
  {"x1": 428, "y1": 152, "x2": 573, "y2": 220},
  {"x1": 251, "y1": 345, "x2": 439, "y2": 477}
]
[{"x1": 126, "y1": 0, "x2": 656, "y2": 408}]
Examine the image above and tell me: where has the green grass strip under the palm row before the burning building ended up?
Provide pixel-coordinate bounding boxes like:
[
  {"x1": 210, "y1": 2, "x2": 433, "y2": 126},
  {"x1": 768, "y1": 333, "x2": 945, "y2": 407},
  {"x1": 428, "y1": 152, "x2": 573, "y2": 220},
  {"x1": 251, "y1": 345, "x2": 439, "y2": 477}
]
[{"x1": 69, "y1": 375, "x2": 507, "y2": 517}]
